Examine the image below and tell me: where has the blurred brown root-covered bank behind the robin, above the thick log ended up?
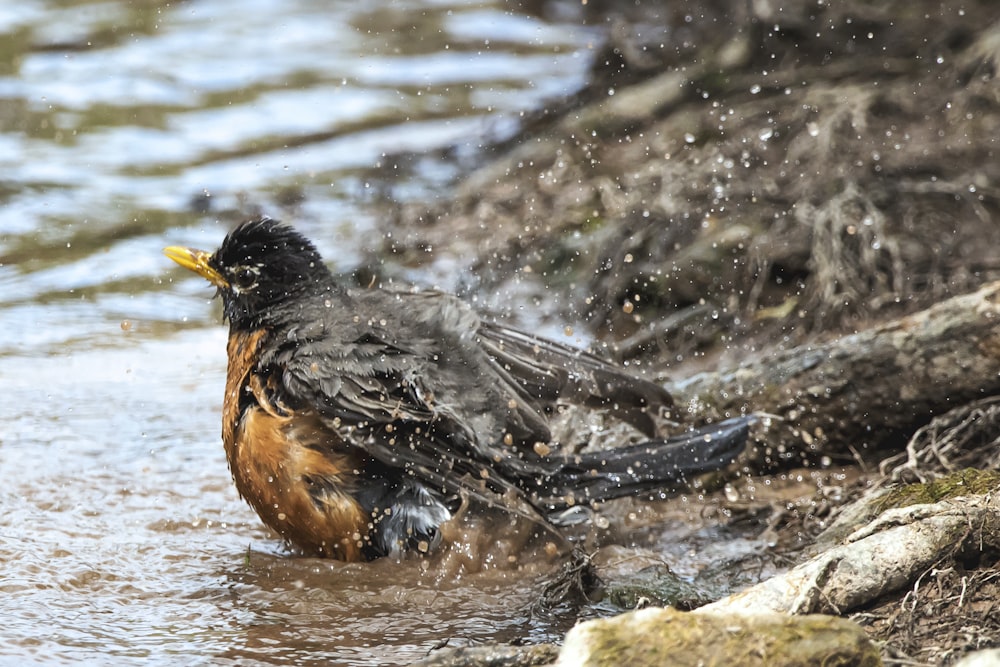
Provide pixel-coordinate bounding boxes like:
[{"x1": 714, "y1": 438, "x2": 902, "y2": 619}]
[{"x1": 372, "y1": 0, "x2": 1000, "y2": 364}]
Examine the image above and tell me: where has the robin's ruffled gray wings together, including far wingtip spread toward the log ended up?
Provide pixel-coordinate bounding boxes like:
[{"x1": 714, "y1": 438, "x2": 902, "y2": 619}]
[{"x1": 265, "y1": 290, "x2": 671, "y2": 516}]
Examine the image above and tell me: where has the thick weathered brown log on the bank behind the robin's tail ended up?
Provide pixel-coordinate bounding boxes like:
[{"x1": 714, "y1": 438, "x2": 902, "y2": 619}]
[{"x1": 671, "y1": 282, "x2": 1000, "y2": 463}]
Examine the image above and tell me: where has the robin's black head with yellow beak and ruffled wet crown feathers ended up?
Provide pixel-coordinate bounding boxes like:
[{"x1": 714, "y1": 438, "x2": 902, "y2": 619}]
[{"x1": 163, "y1": 217, "x2": 332, "y2": 328}]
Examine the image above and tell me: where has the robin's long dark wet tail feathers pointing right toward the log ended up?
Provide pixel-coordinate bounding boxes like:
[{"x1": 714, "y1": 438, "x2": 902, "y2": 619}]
[{"x1": 540, "y1": 415, "x2": 755, "y2": 512}]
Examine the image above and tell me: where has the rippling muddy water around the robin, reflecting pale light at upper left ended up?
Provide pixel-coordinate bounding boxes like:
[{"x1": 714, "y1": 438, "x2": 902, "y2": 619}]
[{"x1": 0, "y1": 0, "x2": 752, "y2": 665}]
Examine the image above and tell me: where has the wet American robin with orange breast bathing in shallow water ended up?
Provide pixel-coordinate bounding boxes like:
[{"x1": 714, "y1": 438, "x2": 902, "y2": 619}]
[{"x1": 164, "y1": 218, "x2": 752, "y2": 561}]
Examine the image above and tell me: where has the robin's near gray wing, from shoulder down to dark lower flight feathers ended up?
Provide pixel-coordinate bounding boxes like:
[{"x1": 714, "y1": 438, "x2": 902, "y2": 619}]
[{"x1": 263, "y1": 291, "x2": 555, "y2": 519}]
